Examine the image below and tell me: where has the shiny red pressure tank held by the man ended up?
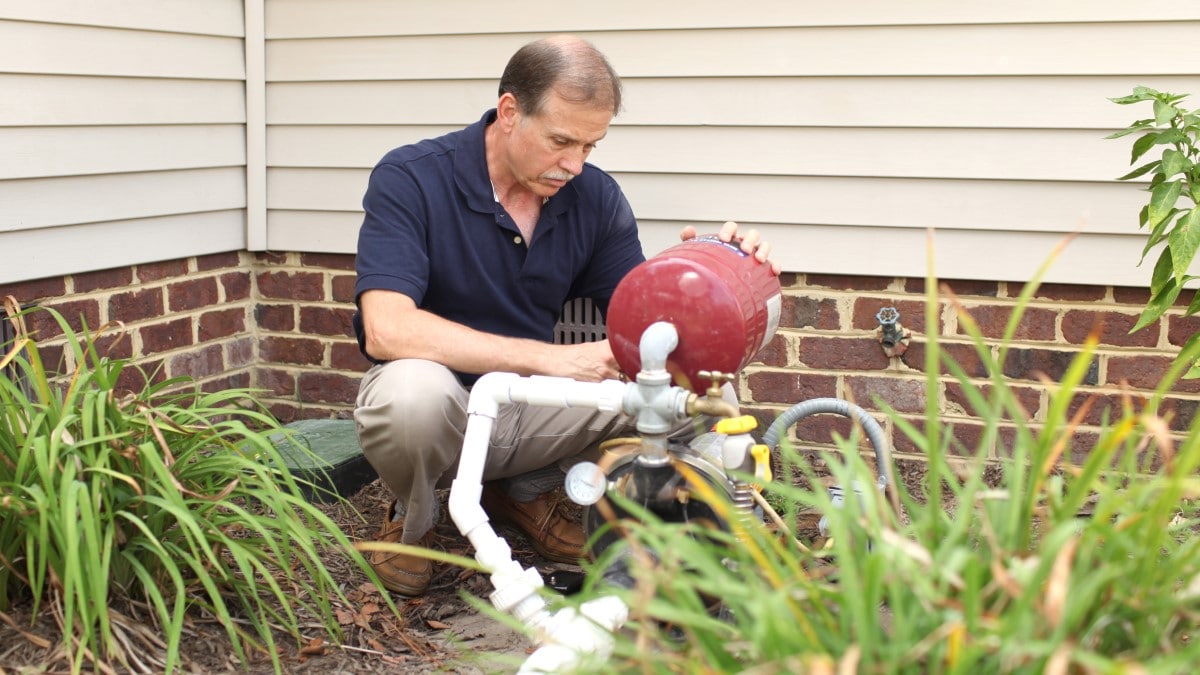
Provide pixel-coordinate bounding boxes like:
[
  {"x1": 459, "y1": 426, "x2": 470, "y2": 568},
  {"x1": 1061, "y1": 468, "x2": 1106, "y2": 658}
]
[{"x1": 607, "y1": 235, "x2": 782, "y2": 393}]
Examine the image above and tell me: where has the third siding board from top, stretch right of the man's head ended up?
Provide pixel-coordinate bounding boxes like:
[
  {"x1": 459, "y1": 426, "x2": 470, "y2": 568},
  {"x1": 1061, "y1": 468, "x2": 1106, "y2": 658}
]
[{"x1": 616, "y1": 76, "x2": 1200, "y2": 130}]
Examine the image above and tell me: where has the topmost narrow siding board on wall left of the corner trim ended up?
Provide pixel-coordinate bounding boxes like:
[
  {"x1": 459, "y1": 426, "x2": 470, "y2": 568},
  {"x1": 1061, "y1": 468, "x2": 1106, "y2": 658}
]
[{"x1": 0, "y1": 0, "x2": 244, "y2": 37}]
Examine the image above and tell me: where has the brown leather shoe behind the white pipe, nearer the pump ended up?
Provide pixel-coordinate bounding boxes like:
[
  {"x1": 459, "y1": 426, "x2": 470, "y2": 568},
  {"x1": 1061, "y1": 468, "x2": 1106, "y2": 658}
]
[{"x1": 482, "y1": 483, "x2": 586, "y2": 565}]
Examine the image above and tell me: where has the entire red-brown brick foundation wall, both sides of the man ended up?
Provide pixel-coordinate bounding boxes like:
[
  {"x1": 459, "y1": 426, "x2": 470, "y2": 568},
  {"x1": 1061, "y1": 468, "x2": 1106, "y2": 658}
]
[{"x1": 0, "y1": 252, "x2": 1200, "y2": 459}]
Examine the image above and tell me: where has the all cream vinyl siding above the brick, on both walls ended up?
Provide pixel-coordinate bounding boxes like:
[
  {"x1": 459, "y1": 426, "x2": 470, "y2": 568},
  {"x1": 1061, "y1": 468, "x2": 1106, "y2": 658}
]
[{"x1": 0, "y1": 0, "x2": 1200, "y2": 286}]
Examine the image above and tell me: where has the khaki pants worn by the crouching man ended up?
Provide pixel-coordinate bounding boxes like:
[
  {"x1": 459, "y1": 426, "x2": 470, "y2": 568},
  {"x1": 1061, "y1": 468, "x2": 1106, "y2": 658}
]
[{"x1": 354, "y1": 359, "x2": 733, "y2": 543}]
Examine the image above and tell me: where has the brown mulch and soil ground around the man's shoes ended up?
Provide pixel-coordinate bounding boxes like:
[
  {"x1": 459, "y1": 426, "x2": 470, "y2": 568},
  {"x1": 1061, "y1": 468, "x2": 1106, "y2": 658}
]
[{"x1": 0, "y1": 454, "x2": 945, "y2": 675}]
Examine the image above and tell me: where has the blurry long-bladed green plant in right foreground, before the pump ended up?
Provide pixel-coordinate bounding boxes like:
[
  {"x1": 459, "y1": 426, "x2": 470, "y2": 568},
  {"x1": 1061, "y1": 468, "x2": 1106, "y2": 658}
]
[{"x1": 549, "y1": 248, "x2": 1200, "y2": 675}]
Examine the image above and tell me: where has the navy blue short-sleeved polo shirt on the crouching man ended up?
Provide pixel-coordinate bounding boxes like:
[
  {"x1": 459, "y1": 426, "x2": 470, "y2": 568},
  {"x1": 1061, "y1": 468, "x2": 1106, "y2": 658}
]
[{"x1": 354, "y1": 109, "x2": 644, "y2": 384}]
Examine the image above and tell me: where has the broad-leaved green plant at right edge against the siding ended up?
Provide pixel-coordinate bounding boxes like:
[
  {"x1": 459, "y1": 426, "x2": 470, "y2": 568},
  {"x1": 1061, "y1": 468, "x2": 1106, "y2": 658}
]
[{"x1": 1108, "y1": 86, "x2": 1200, "y2": 343}]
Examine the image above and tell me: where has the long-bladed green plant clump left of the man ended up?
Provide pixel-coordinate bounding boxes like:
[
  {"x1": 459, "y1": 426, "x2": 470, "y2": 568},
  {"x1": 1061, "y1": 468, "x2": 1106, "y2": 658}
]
[{"x1": 0, "y1": 298, "x2": 395, "y2": 673}]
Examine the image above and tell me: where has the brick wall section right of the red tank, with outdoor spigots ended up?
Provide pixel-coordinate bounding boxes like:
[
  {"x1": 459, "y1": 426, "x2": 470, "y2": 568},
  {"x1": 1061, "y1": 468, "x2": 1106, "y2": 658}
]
[{"x1": 740, "y1": 275, "x2": 1200, "y2": 460}]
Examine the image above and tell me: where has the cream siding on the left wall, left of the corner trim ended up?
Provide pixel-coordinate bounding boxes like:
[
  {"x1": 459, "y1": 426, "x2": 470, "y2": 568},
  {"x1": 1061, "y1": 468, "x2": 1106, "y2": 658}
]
[{"x1": 0, "y1": 0, "x2": 246, "y2": 282}]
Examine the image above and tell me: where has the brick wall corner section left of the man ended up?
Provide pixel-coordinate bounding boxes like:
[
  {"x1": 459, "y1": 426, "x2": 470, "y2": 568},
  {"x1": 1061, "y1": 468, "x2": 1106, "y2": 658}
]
[{"x1": 0, "y1": 252, "x2": 370, "y2": 422}]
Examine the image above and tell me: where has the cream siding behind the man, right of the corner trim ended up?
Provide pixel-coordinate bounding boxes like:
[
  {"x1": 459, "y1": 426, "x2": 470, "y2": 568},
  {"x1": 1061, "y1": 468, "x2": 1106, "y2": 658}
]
[{"x1": 258, "y1": 0, "x2": 1200, "y2": 286}]
